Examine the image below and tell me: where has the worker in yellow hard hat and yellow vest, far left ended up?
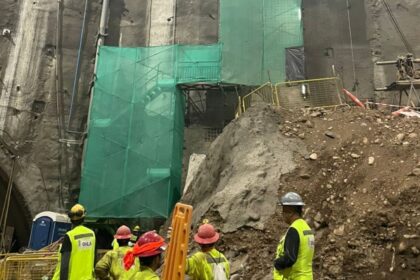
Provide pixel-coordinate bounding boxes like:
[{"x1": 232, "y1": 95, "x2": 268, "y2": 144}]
[{"x1": 53, "y1": 204, "x2": 96, "y2": 280}]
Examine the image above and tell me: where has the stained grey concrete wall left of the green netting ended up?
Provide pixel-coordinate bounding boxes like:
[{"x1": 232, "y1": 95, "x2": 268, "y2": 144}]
[{"x1": 0, "y1": 0, "x2": 101, "y2": 243}]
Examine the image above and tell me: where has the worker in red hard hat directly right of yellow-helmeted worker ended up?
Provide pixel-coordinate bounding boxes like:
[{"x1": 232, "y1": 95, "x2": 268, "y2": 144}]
[{"x1": 95, "y1": 225, "x2": 139, "y2": 280}]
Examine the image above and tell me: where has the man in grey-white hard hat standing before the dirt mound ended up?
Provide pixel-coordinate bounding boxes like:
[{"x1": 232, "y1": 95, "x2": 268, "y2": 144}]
[{"x1": 273, "y1": 192, "x2": 315, "y2": 280}]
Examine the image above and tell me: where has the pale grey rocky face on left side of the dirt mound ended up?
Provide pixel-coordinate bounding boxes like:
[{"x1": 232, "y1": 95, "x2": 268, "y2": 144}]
[{"x1": 183, "y1": 107, "x2": 306, "y2": 232}]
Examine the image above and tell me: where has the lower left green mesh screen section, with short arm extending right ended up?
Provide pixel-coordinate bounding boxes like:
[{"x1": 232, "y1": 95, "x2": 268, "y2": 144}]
[{"x1": 80, "y1": 45, "x2": 220, "y2": 218}]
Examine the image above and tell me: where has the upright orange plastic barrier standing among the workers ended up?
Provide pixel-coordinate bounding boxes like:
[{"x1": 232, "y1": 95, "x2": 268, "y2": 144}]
[{"x1": 162, "y1": 203, "x2": 193, "y2": 280}]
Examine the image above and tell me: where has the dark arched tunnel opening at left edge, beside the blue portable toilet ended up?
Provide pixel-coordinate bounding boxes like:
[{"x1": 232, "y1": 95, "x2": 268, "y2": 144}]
[{"x1": 0, "y1": 169, "x2": 32, "y2": 252}]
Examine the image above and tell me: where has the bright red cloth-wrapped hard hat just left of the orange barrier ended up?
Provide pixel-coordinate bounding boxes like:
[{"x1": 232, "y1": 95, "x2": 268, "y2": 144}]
[{"x1": 136, "y1": 231, "x2": 166, "y2": 257}]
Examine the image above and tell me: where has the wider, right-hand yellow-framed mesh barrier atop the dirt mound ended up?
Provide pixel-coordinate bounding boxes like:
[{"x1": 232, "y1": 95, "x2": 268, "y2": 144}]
[{"x1": 274, "y1": 77, "x2": 343, "y2": 109}]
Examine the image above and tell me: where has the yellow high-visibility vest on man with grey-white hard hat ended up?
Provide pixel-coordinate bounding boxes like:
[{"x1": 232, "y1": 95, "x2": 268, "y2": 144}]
[{"x1": 273, "y1": 219, "x2": 315, "y2": 280}]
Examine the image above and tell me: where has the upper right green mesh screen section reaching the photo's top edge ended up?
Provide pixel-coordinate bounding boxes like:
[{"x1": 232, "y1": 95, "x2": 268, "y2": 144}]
[{"x1": 220, "y1": 0, "x2": 303, "y2": 85}]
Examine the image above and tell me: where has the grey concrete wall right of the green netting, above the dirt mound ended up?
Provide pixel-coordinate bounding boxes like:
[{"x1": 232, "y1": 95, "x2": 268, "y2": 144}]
[{"x1": 302, "y1": 0, "x2": 420, "y2": 102}]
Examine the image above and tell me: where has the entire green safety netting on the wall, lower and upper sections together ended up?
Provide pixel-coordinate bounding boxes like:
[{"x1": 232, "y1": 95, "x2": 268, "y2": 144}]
[{"x1": 79, "y1": 0, "x2": 303, "y2": 218}]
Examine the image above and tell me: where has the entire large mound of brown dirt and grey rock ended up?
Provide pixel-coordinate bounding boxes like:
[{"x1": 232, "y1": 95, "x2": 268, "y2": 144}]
[{"x1": 182, "y1": 104, "x2": 420, "y2": 279}]
